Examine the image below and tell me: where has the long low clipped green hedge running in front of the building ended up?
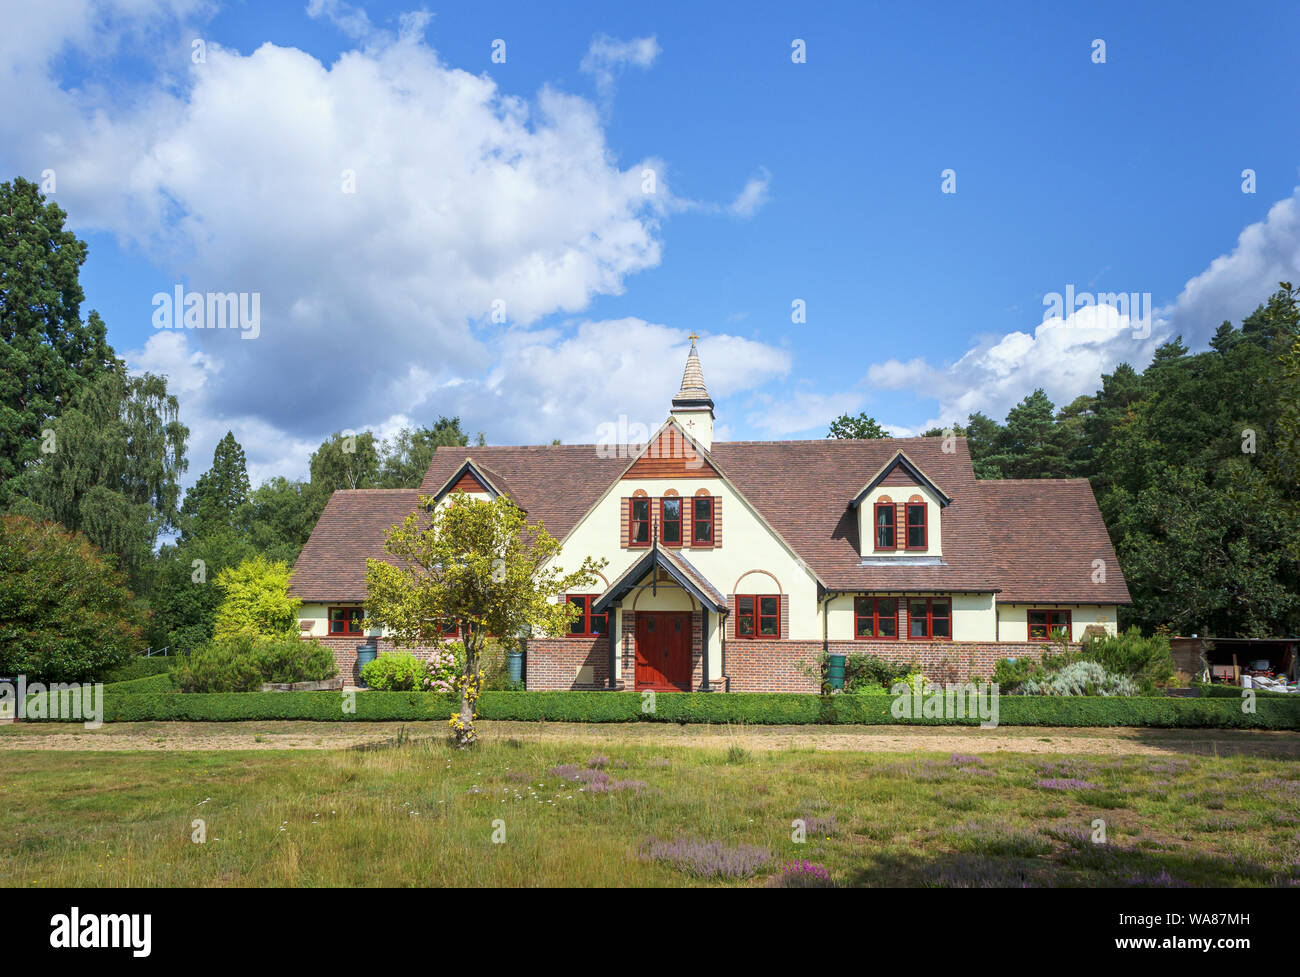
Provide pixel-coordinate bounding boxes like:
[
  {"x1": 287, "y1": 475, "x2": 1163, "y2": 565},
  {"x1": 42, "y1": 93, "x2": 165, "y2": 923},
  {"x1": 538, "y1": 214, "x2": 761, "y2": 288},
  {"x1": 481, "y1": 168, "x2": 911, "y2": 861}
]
[{"x1": 17, "y1": 682, "x2": 1300, "y2": 729}]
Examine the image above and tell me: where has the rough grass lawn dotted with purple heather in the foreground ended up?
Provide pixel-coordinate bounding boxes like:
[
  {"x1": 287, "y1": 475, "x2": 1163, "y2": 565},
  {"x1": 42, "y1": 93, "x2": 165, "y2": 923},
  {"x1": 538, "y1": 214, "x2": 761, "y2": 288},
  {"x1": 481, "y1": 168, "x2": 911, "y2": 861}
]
[{"x1": 0, "y1": 726, "x2": 1300, "y2": 887}]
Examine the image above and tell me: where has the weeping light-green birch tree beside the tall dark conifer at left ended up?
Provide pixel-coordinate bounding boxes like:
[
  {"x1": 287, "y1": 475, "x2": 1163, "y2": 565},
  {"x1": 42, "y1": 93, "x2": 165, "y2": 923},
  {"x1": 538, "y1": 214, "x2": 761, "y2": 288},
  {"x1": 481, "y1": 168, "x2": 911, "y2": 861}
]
[{"x1": 12, "y1": 369, "x2": 190, "y2": 591}]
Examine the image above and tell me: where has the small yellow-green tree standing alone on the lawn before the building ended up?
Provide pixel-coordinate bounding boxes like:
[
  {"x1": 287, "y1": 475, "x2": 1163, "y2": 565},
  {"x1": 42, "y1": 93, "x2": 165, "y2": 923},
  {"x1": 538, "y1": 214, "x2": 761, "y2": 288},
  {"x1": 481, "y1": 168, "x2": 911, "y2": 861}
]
[{"x1": 365, "y1": 494, "x2": 606, "y2": 746}]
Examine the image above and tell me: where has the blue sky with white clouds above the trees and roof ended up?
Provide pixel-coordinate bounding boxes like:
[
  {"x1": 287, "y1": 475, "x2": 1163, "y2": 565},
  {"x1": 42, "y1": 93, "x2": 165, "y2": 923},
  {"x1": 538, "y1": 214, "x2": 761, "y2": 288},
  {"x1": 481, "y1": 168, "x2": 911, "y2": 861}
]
[{"x1": 0, "y1": 0, "x2": 1300, "y2": 483}]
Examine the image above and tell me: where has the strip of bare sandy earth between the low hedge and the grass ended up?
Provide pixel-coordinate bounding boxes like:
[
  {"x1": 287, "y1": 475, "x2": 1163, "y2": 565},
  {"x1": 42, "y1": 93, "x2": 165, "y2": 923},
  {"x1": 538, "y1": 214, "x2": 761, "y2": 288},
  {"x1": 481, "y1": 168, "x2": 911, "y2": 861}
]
[{"x1": 0, "y1": 721, "x2": 1300, "y2": 756}]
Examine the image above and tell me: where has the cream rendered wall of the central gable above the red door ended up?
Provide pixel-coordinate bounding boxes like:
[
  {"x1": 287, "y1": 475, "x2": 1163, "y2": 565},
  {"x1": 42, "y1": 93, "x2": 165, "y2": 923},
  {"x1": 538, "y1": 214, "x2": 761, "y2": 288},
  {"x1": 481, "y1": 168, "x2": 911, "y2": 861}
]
[{"x1": 555, "y1": 476, "x2": 822, "y2": 641}]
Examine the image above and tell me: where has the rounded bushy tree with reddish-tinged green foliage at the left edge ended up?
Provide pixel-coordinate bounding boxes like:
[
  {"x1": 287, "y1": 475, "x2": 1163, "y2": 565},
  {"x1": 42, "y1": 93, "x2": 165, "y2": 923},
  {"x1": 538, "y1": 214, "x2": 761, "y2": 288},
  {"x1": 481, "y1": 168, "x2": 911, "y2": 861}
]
[{"x1": 0, "y1": 516, "x2": 147, "y2": 682}]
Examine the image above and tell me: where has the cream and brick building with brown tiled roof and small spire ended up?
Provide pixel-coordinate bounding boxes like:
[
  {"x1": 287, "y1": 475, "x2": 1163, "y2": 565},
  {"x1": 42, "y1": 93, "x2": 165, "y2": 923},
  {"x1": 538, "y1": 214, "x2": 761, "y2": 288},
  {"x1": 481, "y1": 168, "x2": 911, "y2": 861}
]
[{"x1": 293, "y1": 343, "x2": 1130, "y2": 691}]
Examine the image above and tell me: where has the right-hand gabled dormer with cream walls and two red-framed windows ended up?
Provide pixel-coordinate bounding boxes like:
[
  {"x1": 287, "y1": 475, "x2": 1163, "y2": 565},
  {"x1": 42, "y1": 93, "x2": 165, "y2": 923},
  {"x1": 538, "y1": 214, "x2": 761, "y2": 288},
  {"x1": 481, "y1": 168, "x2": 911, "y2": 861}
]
[{"x1": 849, "y1": 451, "x2": 952, "y2": 563}]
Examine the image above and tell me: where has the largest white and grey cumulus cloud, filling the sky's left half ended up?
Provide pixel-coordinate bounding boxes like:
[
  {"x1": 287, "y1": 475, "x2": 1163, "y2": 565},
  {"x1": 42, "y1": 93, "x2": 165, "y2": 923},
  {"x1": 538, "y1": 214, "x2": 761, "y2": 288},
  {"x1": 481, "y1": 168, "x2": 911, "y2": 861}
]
[{"x1": 0, "y1": 0, "x2": 789, "y2": 477}]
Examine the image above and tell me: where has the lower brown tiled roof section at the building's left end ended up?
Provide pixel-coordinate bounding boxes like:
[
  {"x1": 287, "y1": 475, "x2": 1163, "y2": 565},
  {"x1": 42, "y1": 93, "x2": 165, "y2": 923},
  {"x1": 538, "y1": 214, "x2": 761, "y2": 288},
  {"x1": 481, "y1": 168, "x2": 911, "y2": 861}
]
[{"x1": 290, "y1": 489, "x2": 419, "y2": 602}]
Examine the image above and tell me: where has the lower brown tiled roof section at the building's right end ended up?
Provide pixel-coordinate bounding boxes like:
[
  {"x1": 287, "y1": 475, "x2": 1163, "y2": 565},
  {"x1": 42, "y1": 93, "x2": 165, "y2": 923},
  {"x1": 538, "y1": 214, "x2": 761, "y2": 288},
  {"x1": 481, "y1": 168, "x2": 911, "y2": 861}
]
[{"x1": 978, "y1": 478, "x2": 1130, "y2": 604}]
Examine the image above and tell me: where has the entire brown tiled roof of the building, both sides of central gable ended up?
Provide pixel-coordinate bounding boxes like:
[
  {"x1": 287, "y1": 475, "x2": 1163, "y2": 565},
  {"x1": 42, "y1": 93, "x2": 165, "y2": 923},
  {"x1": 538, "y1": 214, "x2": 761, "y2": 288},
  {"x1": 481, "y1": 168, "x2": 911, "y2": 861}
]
[{"x1": 294, "y1": 438, "x2": 1128, "y2": 603}]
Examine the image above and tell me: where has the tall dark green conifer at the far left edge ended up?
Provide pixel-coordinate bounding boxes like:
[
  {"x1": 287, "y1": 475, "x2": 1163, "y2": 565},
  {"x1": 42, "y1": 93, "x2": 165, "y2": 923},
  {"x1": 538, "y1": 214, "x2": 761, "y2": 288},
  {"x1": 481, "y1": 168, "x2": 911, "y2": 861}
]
[{"x1": 0, "y1": 177, "x2": 117, "y2": 504}]
